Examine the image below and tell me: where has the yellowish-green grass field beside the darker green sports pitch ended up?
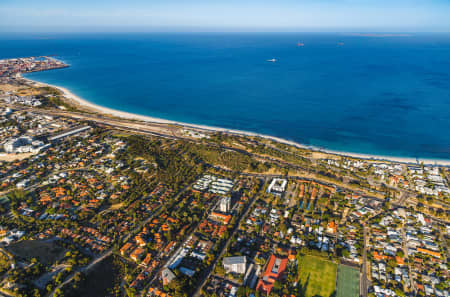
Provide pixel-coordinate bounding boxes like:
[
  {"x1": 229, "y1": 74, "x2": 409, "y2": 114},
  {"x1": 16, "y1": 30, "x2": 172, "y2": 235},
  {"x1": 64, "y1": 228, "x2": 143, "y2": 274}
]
[{"x1": 298, "y1": 255, "x2": 337, "y2": 297}]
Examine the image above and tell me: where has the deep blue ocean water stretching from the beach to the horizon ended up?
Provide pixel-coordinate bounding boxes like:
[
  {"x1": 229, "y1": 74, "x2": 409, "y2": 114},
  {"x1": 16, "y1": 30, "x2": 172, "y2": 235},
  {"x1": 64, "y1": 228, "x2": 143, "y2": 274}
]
[{"x1": 0, "y1": 33, "x2": 450, "y2": 159}]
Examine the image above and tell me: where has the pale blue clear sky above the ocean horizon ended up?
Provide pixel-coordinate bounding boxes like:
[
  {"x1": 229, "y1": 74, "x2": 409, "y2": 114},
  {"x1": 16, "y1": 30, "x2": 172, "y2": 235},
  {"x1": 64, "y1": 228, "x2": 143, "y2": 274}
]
[{"x1": 0, "y1": 0, "x2": 450, "y2": 32}]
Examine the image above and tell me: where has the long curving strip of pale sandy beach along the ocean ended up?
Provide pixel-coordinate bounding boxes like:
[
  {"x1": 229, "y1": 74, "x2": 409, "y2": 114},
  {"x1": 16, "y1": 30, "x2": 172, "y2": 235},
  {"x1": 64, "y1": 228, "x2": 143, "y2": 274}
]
[{"x1": 19, "y1": 75, "x2": 450, "y2": 167}]
